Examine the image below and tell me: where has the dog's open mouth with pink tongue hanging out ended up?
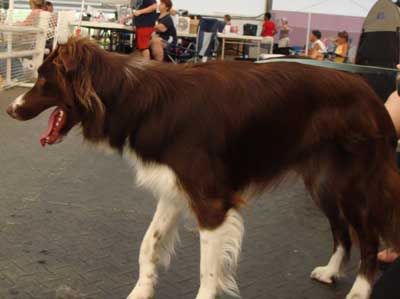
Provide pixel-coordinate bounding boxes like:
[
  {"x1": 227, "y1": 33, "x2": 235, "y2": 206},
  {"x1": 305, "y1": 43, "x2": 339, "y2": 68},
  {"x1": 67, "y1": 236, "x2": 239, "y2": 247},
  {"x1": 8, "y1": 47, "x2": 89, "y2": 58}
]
[{"x1": 40, "y1": 107, "x2": 67, "y2": 147}]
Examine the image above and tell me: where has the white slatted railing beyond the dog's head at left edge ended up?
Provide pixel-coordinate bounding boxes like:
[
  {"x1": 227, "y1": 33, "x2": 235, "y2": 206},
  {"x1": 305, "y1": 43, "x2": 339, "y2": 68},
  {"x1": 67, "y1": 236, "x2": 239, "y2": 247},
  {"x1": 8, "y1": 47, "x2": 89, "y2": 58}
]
[{"x1": 0, "y1": 9, "x2": 75, "y2": 90}]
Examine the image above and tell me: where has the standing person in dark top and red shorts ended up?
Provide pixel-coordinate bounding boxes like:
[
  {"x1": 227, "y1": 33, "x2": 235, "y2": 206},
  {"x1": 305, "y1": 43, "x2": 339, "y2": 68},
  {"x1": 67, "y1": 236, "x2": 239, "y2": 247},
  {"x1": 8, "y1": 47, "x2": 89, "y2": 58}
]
[{"x1": 133, "y1": 0, "x2": 157, "y2": 60}]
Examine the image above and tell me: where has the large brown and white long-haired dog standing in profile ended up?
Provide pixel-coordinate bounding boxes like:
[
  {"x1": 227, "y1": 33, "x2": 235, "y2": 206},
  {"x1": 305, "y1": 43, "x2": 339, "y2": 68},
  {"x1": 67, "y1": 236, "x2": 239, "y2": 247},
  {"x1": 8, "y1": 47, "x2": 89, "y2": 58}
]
[{"x1": 8, "y1": 39, "x2": 400, "y2": 299}]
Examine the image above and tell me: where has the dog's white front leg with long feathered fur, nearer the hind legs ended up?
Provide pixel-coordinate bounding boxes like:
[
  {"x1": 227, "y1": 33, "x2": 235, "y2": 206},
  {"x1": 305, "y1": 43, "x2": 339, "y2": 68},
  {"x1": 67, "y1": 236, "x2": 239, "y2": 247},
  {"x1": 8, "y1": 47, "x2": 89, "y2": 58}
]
[{"x1": 196, "y1": 208, "x2": 244, "y2": 299}]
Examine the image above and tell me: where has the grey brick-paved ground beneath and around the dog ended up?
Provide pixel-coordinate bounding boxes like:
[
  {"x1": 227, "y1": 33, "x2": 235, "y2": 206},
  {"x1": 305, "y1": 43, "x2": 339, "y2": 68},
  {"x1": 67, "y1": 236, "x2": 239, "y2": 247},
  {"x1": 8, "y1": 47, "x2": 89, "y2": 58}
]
[{"x1": 0, "y1": 89, "x2": 357, "y2": 299}]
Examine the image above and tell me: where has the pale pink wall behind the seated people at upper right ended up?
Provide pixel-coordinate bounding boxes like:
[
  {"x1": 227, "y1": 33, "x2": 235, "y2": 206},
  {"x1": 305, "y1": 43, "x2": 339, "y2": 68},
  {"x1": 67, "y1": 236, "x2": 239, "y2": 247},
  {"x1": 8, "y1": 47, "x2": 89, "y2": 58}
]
[{"x1": 273, "y1": 10, "x2": 364, "y2": 46}]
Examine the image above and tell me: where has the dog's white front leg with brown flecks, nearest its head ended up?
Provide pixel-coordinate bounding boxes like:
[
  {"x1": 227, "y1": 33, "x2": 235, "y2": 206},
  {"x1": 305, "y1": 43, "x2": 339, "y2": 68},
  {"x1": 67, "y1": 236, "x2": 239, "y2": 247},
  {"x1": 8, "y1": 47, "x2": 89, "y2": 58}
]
[{"x1": 128, "y1": 197, "x2": 187, "y2": 299}]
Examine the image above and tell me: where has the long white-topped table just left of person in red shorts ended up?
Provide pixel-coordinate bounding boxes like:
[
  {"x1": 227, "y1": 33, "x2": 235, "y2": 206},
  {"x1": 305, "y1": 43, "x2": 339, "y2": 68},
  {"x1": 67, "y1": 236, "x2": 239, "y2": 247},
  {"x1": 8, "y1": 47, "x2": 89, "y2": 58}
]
[{"x1": 69, "y1": 21, "x2": 134, "y2": 53}]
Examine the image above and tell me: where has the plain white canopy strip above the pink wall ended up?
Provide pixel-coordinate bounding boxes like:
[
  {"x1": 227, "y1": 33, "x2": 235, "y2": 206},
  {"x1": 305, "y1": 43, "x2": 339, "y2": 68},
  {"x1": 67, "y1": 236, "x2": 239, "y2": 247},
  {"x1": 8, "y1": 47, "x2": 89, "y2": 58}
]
[{"x1": 272, "y1": 0, "x2": 376, "y2": 17}]
